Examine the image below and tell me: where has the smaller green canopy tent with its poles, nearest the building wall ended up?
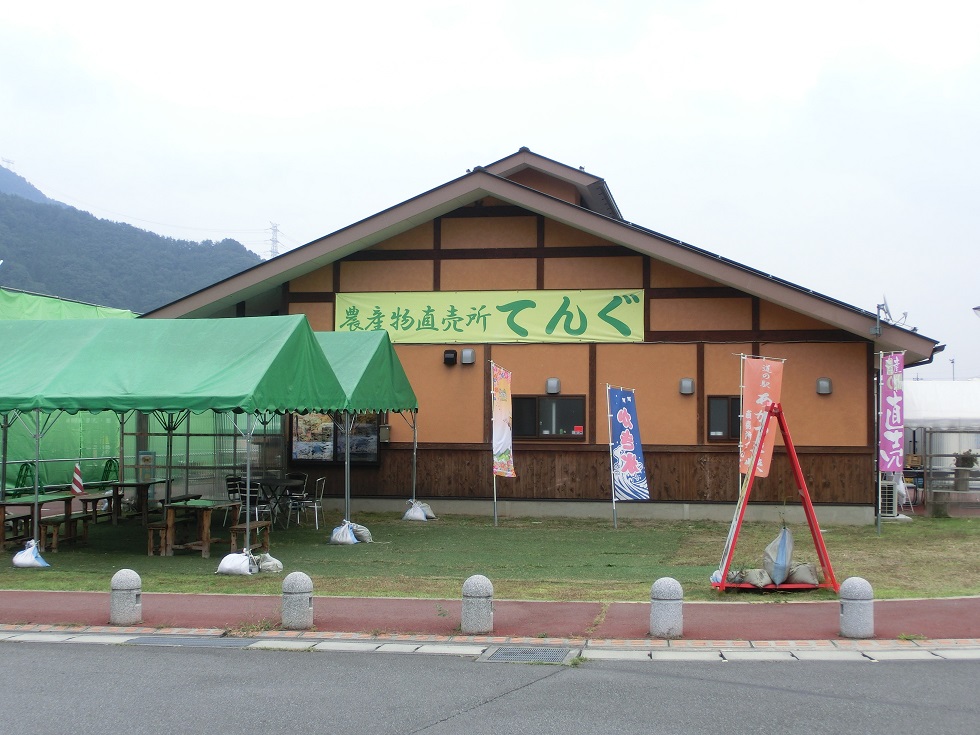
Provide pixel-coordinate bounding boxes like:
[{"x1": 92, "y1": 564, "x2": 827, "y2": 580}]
[{"x1": 316, "y1": 330, "x2": 419, "y2": 519}]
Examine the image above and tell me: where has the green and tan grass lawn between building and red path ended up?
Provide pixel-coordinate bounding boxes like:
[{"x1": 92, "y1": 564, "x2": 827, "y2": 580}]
[{"x1": 0, "y1": 509, "x2": 980, "y2": 602}]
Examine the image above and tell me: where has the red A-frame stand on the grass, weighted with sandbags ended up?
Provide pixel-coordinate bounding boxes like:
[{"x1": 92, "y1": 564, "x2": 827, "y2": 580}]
[{"x1": 711, "y1": 403, "x2": 840, "y2": 592}]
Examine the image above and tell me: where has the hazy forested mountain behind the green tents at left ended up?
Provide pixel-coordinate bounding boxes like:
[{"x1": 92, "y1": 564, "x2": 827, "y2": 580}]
[{"x1": 0, "y1": 167, "x2": 262, "y2": 313}]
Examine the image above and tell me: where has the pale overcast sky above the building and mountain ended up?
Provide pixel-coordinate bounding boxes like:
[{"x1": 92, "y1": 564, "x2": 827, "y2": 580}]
[{"x1": 0, "y1": 0, "x2": 980, "y2": 380}]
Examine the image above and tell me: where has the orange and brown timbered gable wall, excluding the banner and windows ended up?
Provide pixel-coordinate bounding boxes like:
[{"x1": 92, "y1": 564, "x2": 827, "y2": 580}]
[{"x1": 289, "y1": 202, "x2": 873, "y2": 503}]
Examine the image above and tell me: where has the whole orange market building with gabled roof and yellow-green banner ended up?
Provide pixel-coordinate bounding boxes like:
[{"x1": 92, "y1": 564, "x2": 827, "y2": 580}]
[{"x1": 145, "y1": 148, "x2": 942, "y2": 520}]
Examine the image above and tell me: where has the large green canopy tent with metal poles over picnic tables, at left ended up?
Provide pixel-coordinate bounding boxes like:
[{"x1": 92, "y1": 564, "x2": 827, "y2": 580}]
[{"x1": 0, "y1": 315, "x2": 347, "y2": 556}]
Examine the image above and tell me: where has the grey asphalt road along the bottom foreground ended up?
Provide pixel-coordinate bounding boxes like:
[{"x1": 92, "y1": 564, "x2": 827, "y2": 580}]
[{"x1": 0, "y1": 641, "x2": 980, "y2": 735}]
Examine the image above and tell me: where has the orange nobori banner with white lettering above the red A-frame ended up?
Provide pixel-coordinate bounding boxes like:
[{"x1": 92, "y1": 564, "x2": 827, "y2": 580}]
[{"x1": 738, "y1": 356, "x2": 783, "y2": 477}]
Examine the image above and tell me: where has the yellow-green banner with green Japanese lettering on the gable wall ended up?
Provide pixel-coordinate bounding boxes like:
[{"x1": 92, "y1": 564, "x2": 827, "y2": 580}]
[{"x1": 334, "y1": 290, "x2": 644, "y2": 344}]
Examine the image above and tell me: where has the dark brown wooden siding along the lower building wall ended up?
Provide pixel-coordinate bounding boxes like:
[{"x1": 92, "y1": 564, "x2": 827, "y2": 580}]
[{"x1": 306, "y1": 445, "x2": 874, "y2": 505}]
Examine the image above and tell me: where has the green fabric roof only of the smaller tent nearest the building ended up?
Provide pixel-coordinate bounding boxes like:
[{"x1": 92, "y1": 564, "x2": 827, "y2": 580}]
[{"x1": 316, "y1": 329, "x2": 419, "y2": 411}]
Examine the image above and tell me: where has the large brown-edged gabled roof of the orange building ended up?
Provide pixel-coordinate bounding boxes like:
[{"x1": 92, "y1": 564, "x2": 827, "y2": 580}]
[{"x1": 144, "y1": 148, "x2": 942, "y2": 366}]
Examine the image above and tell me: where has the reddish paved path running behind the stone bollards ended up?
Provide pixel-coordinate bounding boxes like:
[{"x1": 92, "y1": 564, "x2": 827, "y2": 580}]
[{"x1": 0, "y1": 591, "x2": 980, "y2": 640}]
